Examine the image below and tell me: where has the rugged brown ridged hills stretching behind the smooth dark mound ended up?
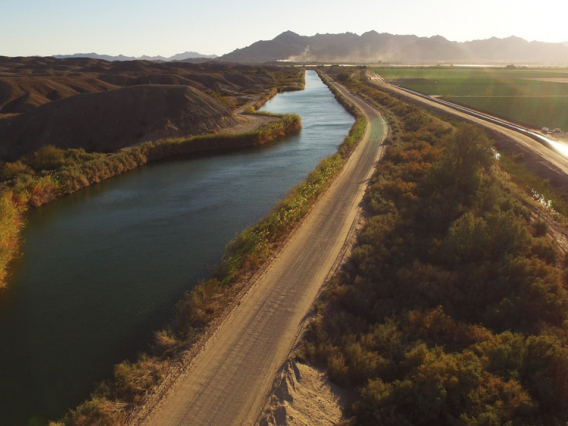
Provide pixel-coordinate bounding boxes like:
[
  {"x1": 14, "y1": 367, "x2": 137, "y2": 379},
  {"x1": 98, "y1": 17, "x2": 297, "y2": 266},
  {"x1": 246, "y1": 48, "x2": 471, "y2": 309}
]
[{"x1": 0, "y1": 57, "x2": 275, "y2": 114}]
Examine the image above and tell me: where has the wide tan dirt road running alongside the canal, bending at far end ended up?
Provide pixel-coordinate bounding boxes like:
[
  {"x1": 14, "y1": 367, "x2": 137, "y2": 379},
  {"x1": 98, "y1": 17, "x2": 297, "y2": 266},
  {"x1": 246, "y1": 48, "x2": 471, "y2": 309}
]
[{"x1": 142, "y1": 78, "x2": 386, "y2": 426}]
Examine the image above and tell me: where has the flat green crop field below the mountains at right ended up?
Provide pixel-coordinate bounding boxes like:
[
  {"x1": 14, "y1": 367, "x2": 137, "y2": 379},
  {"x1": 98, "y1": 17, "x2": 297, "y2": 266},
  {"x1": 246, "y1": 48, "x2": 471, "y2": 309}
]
[{"x1": 374, "y1": 67, "x2": 568, "y2": 130}]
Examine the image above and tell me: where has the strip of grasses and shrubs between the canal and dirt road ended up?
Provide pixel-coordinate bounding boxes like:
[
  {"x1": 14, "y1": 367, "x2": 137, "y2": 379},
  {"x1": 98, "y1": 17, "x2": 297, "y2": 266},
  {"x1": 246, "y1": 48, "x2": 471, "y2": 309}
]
[{"x1": 53, "y1": 71, "x2": 367, "y2": 425}]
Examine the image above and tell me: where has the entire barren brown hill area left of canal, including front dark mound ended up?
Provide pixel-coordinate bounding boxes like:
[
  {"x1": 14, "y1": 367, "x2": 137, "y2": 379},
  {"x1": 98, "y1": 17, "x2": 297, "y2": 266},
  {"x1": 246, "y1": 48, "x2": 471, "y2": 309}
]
[{"x1": 0, "y1": 57, "x2": 286, "y2": 160}]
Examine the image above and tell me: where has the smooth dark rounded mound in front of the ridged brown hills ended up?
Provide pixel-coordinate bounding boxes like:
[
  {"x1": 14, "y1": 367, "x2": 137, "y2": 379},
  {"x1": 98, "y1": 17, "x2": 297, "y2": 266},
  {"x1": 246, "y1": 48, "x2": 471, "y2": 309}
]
[{"x1": 0, "y1": 85, "x2": 235, "y2": 158}]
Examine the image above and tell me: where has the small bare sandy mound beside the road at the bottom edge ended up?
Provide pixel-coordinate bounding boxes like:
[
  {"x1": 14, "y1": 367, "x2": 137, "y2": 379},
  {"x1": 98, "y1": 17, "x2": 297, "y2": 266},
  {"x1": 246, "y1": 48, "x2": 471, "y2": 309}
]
[{"x1": 257, "y1": 361, "x2": 346, "y2": 426}]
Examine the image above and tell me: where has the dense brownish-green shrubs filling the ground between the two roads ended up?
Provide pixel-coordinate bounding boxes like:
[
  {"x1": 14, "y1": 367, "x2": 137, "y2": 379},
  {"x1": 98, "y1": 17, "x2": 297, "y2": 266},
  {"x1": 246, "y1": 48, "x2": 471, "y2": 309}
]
[{"x1": 297, "y1": 74, "x2": 568, "y2": 425}]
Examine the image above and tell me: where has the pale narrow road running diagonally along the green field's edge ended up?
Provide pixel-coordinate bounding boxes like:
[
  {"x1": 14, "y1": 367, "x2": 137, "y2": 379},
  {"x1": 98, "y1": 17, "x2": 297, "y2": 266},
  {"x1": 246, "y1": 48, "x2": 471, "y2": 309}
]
[{"x1": 368, "y1": 74, "x2": 568, "y2": 176}]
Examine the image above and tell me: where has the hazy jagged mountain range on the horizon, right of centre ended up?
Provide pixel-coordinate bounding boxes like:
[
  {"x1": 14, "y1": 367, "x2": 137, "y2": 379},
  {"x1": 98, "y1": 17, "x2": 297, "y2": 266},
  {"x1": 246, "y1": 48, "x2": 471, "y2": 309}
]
[{"x1": 219, "y1": 31, "x2": 568, "y2": 64}]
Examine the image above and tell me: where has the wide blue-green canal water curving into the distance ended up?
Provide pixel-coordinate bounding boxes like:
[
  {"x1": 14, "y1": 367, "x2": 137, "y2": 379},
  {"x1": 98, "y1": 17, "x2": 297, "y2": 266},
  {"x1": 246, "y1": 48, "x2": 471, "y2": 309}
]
[{"x1": 0, "y1": 71, "x2": 353, "y2": 426}]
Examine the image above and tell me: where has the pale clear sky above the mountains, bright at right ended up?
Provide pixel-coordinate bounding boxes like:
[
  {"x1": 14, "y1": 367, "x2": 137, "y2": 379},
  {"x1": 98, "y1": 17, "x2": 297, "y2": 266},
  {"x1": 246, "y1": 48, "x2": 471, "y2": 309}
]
[{"x1": 0, "y1": 0, "x2": 568, "y2": 56}]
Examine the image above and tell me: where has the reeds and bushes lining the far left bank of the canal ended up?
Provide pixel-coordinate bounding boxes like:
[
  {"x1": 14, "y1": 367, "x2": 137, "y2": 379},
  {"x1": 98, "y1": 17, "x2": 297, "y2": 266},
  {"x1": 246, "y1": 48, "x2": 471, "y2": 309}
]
[{"x1": 0, "y1": 114, "x2": 301, "y2": 289}]
